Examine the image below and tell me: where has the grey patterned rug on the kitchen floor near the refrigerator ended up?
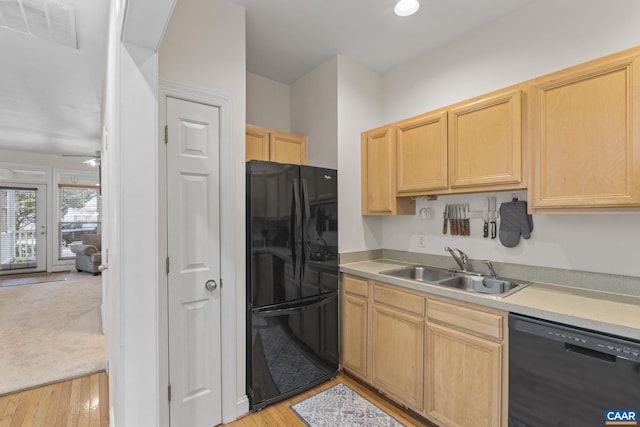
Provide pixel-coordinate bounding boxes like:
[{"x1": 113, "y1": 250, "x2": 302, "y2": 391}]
[{"x1": 291, "y1": 383, "x2": 404, "y2": 427}]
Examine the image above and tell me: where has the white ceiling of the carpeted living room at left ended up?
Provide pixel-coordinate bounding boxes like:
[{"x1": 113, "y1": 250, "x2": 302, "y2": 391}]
[{"x1": 0, "y1": 0, "x2": 109, "y2": 155}]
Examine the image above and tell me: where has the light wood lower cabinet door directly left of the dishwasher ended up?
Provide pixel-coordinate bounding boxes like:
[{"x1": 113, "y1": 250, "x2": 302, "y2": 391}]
[{"x1": 425, "y1": 323, "x2": 502, "y2": 427}]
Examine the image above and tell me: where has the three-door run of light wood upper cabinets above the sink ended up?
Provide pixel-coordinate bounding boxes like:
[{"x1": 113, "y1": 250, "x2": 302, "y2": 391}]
[{"x1": 362, "y1": 86, "x2": 526, "y2": 209}]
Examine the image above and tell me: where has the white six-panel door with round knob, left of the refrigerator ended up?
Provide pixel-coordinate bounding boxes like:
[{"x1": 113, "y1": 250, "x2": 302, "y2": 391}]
[{"x1": 166, "y1": 97, "x2": 222, "y2": 427}]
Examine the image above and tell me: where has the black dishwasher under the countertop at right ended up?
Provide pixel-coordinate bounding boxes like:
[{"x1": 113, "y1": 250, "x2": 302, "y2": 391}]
[{"x1": 509, "y1": 314, "x2": 640, "y2": 427}]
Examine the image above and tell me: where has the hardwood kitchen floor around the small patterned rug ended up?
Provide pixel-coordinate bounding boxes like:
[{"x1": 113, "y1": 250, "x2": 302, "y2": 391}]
[{"x1": 225, "y1": 373, "x2": 433, "y2": 427}]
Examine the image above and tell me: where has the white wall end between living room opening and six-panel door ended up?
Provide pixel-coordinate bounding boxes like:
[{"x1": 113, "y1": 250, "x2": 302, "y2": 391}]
[{"x1": 102, "y1": 2, "x2": 164, "y2": 426}]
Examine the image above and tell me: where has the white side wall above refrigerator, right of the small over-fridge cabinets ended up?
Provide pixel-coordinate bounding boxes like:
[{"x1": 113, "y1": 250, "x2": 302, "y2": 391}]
[{"x1": 291, "y1": 57, "x2": 338, "y2": 169}]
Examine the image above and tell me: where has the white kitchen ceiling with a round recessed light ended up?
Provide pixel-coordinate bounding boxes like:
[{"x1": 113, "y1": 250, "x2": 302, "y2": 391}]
[{"x1": 231, "y1": 0, "x2": 532, "y2": 84}]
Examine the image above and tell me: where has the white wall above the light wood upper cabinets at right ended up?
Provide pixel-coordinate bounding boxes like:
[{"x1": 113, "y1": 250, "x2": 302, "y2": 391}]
[{"x1": 381, "y1": 0, "x2": 640, "y2": 124}]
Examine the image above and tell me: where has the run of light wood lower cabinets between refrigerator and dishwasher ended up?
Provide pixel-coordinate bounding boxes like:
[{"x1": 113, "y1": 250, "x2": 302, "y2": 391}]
[{"x1": 341, "y1": 274, "x2": 507, "y2": 427}]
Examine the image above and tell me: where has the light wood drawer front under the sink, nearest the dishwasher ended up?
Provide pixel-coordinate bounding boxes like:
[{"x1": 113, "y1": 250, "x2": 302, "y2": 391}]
[{"x1": 427, "y1": 299, "x2": 504, "y2": 341}]
